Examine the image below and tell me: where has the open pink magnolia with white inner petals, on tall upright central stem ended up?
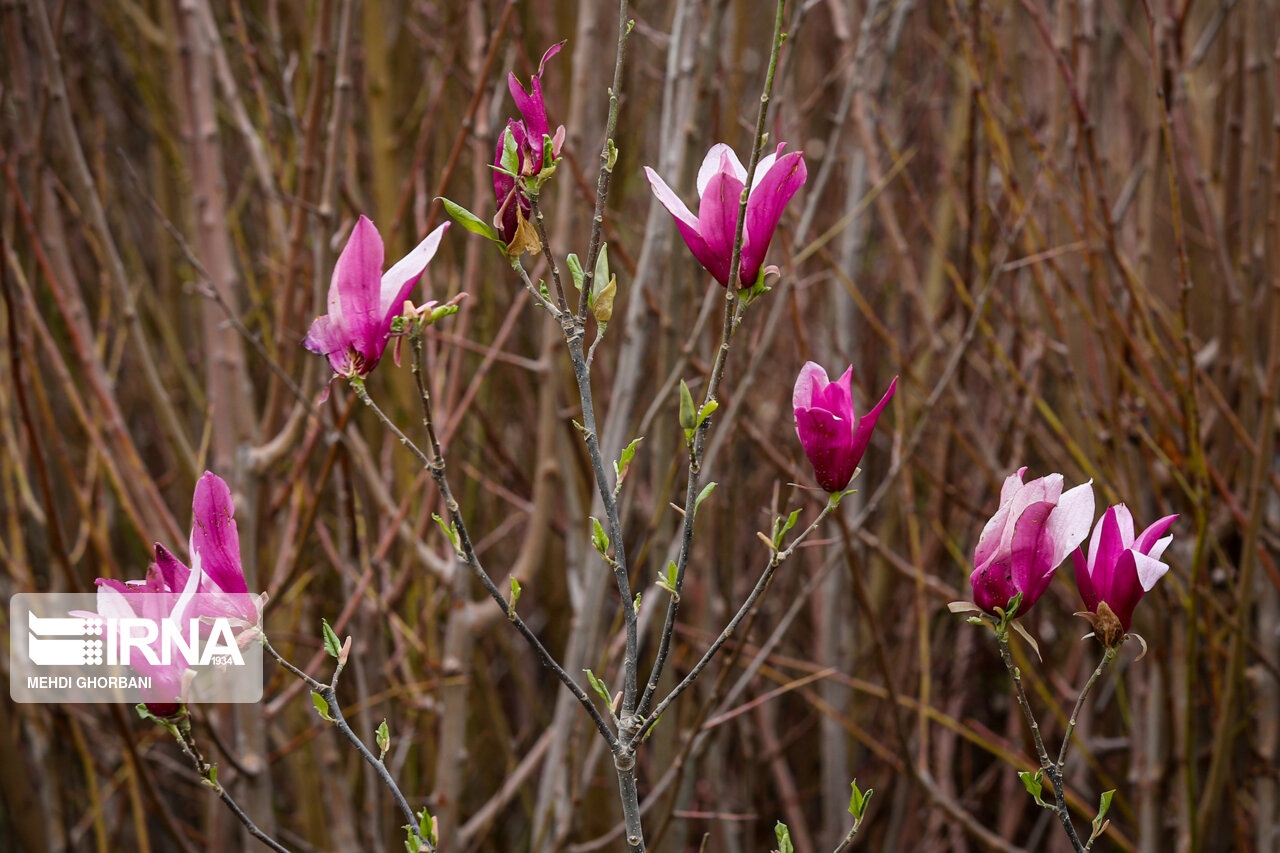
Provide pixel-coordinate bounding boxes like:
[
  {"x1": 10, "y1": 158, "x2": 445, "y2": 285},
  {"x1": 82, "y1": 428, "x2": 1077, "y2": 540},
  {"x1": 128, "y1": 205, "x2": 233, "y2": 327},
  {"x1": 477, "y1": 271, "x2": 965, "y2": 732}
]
[{"x1": 644, "y1": 142, "x2": 809, "y2": 287}]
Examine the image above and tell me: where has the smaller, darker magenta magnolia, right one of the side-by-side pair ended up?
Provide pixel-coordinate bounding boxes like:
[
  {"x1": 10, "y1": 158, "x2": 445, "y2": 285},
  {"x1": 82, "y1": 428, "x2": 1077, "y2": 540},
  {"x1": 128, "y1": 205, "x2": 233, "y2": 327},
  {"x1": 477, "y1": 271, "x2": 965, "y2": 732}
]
[{"x1": 1071, "y1": 503, "x2": 1178, "y2": 635}]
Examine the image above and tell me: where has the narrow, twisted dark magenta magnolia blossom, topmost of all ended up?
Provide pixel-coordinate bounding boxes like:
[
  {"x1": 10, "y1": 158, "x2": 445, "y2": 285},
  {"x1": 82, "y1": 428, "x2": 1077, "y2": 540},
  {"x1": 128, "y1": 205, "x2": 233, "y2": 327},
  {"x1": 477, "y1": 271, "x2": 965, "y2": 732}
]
[{"x1": 493, "y1": 42, "x2": 564, "y2": 243}]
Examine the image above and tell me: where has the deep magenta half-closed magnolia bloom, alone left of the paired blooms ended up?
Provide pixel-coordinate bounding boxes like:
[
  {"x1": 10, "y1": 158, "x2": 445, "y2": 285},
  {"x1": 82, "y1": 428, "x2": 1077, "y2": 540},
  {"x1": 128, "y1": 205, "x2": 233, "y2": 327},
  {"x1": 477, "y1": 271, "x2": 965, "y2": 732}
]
[{"x1": 791, "y1": 361, "x2": 897, "y2": 492}]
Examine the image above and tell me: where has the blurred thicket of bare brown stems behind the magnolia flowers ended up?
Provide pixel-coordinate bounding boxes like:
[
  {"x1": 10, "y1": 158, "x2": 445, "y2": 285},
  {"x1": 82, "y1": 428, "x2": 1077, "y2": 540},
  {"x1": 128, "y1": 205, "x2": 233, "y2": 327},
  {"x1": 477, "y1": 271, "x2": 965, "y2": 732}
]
[{"x1": 0, "y1": 0, "x2": 1280, "y2": 853}]
